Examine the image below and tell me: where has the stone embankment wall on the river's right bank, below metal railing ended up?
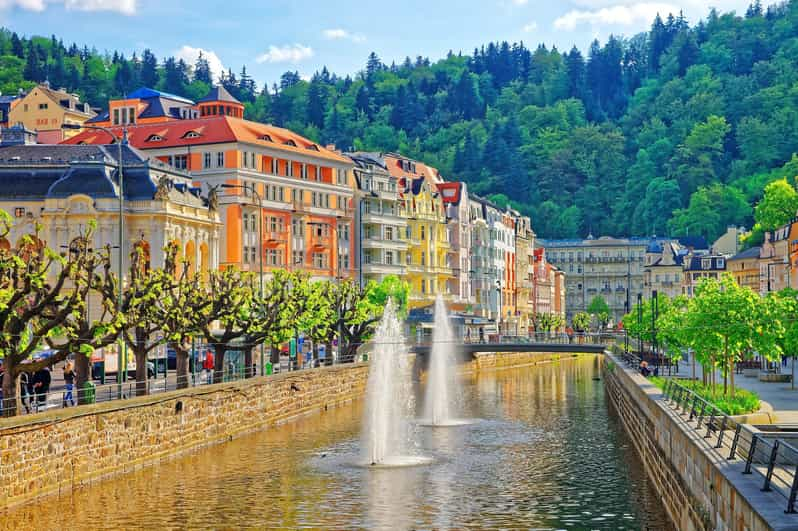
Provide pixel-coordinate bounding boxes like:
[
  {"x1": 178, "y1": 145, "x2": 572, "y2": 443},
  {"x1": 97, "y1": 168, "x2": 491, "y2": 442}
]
[{"x1": 603, "y1": 355, "x2": 796, "y2": 531}]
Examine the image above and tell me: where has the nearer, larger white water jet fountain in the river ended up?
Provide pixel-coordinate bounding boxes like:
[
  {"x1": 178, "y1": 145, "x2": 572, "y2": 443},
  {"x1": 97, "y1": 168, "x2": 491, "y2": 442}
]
[{"x1": 363, "y1": 301, "x2": 431, "y2": 467}]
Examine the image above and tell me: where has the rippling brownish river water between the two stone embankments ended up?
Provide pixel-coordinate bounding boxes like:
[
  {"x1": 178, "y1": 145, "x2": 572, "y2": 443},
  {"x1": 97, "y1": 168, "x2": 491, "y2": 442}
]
[{"x1": 0, "y1": 358, "x2": 670, "y2": 530}]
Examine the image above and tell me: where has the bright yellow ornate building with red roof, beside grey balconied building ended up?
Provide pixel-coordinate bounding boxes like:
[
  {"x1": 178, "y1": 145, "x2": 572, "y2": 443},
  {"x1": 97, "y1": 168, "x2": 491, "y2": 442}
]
[{"x1": 384, "y1": 154, "x2": 454, "y2": 309}]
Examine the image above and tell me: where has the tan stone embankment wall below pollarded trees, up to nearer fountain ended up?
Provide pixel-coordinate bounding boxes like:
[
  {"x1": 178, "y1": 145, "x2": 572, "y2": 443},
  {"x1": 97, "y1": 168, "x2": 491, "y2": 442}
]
[{"x1": 0, "y1": 364, "x2": 368, "y2": 510}]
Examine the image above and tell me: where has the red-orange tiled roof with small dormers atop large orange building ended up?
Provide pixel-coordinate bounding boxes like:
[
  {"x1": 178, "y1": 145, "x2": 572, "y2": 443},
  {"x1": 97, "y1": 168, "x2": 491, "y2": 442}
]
[{"x1": 63, "y1": 116, "x2": 351, "y2": 163}]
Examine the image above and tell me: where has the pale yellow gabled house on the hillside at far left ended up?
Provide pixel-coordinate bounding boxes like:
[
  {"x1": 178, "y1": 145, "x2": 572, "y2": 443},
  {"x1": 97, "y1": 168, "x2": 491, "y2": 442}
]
[{"x1": 8, "y1": 83, "x2": 96, "y2": 144}]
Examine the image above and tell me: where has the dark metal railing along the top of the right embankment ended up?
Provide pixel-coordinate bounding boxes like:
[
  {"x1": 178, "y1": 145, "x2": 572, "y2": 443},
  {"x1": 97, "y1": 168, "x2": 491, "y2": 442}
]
[{"x1": 663, "y1": 379, "x2": 798, "y2": 514}]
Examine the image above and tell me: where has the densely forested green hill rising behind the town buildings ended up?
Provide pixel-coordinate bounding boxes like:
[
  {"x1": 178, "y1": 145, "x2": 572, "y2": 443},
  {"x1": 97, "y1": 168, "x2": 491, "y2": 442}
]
[{"x1": 0, "y1": 0, "x2": 798, "y2": 239}]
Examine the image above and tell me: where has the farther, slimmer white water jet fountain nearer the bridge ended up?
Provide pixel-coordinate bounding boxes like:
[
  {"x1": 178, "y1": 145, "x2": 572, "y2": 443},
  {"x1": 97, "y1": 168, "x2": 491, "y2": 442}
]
[{"x1": 421, "y1": 295, "x2": 468, "y2": 427}]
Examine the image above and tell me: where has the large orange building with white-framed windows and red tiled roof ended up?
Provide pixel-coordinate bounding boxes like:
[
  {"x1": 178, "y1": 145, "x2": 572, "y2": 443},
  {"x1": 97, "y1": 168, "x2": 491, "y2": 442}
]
[{"x1": 67, "y1": 88, "x2": 355, "y2": 279}]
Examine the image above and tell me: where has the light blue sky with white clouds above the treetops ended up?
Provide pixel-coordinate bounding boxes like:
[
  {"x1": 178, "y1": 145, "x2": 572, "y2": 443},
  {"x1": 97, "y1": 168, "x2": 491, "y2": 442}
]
[{"x1": 0, "y1": 0, "x2": 770, "y2": 85}]
